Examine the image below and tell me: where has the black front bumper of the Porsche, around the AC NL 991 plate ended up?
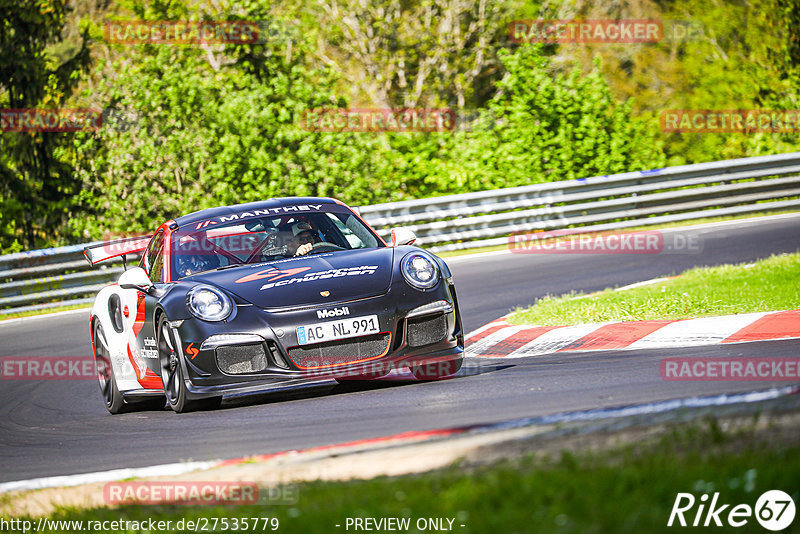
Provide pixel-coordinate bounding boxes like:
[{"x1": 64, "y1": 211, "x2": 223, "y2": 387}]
[{"x1": 173, "y1": 279, "x2": 464, "y2": 398}]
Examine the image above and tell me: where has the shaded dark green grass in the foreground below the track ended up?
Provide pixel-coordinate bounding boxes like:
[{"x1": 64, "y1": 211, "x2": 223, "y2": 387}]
[{"x1": 7, "y1": 419, "x2": 800, "y2": 534}]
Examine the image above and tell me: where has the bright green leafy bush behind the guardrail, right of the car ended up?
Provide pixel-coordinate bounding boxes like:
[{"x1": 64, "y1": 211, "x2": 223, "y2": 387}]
[{"x1": 448, "y1": 46, "x2": 664, "y2": 190}]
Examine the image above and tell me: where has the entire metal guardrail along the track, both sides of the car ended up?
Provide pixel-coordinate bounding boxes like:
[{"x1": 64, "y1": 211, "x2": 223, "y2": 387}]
[{"x1": 0, "y1": 152, "x2": 800, "y2": 314}]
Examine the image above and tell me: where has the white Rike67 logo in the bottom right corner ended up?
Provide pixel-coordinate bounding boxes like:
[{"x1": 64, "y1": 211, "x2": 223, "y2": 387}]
[{"x1": 667, "y1": 490, "x2": 796, "y2": 532}]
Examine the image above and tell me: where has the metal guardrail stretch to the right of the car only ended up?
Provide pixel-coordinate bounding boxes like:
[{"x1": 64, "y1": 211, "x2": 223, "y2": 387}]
[{"x1": 360, "y1": 152, "x2": 800, "y2": 252}]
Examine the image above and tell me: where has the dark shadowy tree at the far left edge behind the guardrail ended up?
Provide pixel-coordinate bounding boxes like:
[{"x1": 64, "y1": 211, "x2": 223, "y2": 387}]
[{"x1": 0, "y1": 0, "x2": 90, "y2": 251}]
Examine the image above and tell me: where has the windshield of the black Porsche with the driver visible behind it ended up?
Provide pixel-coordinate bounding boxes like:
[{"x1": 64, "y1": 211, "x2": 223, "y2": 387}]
[{"x1": 171, "y1": 204, "x2": 384, "y2": 279}]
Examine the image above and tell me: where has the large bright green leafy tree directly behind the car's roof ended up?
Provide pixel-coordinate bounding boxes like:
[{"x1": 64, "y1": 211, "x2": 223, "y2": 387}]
[{"x1": 71, "y1": 1, "x2": 399, "y2": 239}]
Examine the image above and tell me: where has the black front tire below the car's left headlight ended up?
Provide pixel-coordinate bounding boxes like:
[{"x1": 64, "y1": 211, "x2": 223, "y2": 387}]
[{"x1": 156, "y1": 315, "x2": 222, "y2": 413}]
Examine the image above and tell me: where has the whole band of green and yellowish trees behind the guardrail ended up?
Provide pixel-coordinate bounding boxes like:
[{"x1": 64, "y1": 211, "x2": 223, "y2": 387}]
[{"x1": 0, "y1": 0, "x2": 800, "y2": 252}]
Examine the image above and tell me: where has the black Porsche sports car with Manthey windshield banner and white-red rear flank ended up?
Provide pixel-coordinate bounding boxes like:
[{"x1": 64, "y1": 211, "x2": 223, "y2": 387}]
[{"x1": 84, "y1": 198, "x2": 464, "y2": 413}]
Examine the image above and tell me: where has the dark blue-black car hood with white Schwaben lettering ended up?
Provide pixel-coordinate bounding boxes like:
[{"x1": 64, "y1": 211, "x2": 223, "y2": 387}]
[{"x1": 187, "y1": 247, "x2": 394, "y2": 308}]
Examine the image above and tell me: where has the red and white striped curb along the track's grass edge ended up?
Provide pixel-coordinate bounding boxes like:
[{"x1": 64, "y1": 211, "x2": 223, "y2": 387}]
[{"x1": 465, "y1": 310, "x2": 800, "y2": 358}]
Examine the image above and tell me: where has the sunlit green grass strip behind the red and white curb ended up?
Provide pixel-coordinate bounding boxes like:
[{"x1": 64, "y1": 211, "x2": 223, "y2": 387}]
[{"x1": 509, "y1": 253, "x2": 800, "y2": 325}]
